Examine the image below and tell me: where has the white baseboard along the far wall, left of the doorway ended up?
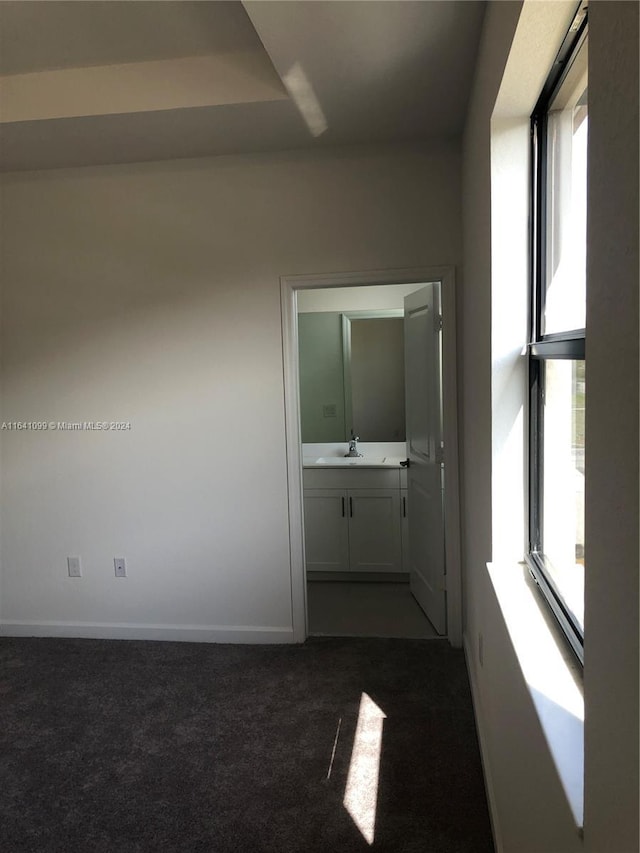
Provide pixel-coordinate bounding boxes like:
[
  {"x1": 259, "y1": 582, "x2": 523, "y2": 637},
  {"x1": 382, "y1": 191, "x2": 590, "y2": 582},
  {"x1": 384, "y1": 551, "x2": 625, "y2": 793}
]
[{"x1": 0, "y1": 621, "x2": 294, "y2": 644}]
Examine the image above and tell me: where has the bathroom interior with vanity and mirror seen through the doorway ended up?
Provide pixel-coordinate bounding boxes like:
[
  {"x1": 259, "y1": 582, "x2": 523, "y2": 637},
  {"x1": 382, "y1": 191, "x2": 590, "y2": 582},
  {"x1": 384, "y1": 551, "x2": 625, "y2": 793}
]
[{"x1": 297, "y1": 283, "x2": 446, "y2": 638}]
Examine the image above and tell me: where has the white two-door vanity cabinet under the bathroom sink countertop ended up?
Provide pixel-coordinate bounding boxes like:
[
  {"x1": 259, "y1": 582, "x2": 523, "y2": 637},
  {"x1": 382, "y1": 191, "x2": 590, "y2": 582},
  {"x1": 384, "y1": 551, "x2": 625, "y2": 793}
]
[{"x1": 304, "y1": 462, "x2": 406, "y2": 573}]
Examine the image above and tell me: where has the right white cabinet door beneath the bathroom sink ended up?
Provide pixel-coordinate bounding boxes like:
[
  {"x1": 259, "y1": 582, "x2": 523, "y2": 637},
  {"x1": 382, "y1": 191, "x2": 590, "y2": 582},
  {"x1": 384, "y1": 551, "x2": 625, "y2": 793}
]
[{"x1": 348, "y1": 489, "x2": 402, "y2": 572}]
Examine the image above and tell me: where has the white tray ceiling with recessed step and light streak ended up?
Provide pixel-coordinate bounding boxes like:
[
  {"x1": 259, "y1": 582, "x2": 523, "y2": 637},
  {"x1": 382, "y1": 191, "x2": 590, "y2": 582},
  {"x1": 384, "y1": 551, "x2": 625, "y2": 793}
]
[{"x1": 0, "y1": 0, "x2": 485, "y2": 171}]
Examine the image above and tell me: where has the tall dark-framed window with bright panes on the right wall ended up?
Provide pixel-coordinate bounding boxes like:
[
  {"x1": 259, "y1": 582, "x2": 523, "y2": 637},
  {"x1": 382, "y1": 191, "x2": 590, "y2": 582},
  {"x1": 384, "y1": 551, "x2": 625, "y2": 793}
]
[{"x1": 528, "y1": 8, "x2": 588, "y2": 661}]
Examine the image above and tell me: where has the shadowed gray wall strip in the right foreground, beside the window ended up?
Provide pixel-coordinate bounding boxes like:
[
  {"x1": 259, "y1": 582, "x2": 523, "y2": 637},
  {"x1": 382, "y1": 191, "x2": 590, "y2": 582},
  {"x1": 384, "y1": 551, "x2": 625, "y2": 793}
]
[{"x1": 585, "y1": 2, "x2": 640, "y2": 853}]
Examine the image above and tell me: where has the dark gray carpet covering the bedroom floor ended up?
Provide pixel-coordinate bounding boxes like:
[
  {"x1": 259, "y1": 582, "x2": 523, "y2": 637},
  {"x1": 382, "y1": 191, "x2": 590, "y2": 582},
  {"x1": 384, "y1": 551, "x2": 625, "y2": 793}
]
[{"x1": 0, "y1": 639, "x2": 493, "y2": 853}]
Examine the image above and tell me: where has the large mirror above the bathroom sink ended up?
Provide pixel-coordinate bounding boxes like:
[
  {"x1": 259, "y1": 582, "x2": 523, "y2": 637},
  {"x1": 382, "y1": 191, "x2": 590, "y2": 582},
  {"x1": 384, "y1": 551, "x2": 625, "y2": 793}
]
[{"x1": 298, "y1": 309, "x2": 405, "y2": 443}]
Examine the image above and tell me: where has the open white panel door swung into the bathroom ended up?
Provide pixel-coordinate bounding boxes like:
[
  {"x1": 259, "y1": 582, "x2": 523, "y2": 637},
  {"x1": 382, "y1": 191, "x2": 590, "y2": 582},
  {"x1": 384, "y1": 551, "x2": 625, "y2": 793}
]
[{"x1": 404, "y1": 282, "x2": 447, "y2": 634}]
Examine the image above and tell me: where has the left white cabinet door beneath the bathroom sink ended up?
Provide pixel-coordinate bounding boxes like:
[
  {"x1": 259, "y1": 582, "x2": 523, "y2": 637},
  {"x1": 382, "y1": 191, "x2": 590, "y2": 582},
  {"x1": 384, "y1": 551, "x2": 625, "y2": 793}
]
[{"x1": 304, "y1": 489, "x2": 349, "y2": 572}]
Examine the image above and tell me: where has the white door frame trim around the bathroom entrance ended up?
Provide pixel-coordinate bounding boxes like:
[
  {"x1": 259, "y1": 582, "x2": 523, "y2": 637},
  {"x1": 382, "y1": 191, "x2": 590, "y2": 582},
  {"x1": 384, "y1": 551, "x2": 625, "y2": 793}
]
[{"x1": 280, "y1": 266, "x2": 462, "y2": 647}]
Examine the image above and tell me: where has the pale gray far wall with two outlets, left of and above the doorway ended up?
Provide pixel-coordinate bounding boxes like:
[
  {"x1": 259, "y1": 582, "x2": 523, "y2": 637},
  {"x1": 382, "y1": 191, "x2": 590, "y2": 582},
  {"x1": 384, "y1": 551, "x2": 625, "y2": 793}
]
[{"x1": 0, "y1": 143, "x2": 461, "y2": 640}]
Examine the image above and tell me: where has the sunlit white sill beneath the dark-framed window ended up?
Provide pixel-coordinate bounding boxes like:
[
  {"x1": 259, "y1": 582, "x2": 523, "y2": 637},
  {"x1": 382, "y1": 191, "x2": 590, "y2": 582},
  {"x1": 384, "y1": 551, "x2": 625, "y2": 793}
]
[{"x1": 487, "y1": 563, "x2": 584, "y2": 831}]
